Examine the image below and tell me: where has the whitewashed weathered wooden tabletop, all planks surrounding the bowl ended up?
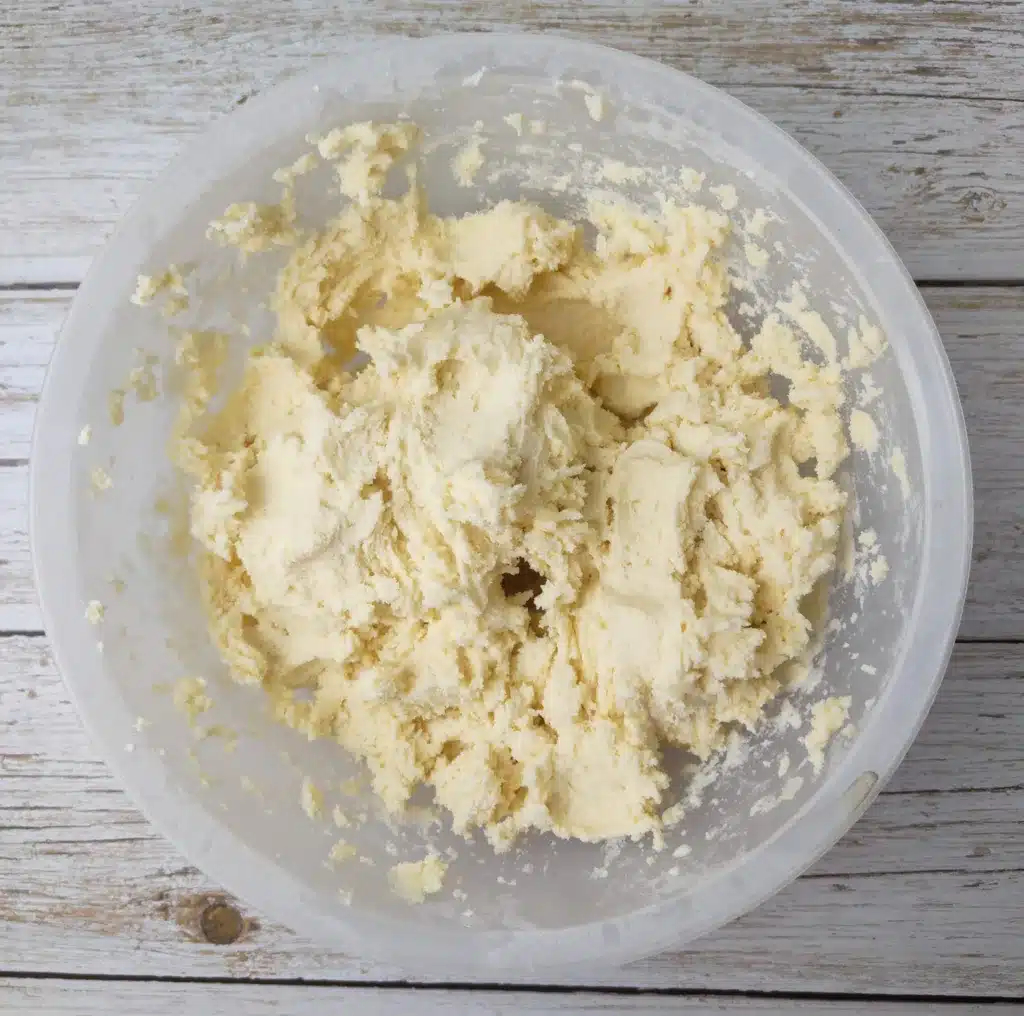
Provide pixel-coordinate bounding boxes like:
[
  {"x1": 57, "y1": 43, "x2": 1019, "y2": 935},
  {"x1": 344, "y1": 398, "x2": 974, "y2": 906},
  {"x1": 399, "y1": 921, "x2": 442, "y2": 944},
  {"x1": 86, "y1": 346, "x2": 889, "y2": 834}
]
[{"x1": 0, "y1": 0, "x2": 1024, "y2": 1016}]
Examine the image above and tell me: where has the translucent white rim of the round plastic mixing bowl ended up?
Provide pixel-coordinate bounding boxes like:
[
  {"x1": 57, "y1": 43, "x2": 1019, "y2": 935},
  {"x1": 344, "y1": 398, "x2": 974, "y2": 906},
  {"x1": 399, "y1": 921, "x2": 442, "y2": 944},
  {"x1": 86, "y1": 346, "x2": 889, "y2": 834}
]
[{"x1": 30, "y1": 32, "x2": 973, "y2": 979}]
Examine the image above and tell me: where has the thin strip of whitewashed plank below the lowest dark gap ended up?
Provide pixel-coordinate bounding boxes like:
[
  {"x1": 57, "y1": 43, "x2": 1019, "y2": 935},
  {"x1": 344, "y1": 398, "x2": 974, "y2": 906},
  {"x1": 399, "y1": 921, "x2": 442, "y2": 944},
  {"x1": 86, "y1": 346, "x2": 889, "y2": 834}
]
[{"x1": 0, "y1": 977, "x2": 1024, "y2": 1016}]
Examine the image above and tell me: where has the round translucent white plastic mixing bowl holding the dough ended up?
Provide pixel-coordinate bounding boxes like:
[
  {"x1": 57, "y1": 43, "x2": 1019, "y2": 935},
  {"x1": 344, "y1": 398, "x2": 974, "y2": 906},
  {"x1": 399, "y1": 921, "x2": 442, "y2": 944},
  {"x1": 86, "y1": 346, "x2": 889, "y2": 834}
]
[{"x1": 32, "y1": 35, "x2": 972, "y2": 979}]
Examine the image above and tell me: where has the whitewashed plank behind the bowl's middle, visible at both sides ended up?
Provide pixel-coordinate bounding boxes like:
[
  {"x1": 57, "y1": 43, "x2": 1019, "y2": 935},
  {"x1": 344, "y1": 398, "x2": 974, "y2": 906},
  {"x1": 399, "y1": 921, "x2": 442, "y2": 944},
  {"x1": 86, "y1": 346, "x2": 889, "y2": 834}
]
[{"x1": 0, "y1": 287, "x2": 1024, "y2": 639}]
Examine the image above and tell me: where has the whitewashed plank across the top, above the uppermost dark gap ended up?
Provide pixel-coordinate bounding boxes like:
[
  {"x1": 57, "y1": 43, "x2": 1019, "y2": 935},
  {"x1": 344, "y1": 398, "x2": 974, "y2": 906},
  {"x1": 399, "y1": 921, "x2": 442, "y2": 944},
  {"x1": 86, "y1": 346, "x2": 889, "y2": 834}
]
[{"x1": 0, "y1": 0, "x2": 1024, "y2": 284}]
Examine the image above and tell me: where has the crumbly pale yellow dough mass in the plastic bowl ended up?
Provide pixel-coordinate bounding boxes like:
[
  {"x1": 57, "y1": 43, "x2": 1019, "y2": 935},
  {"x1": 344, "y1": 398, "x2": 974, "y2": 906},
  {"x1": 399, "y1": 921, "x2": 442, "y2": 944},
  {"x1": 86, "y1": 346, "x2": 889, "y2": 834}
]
[{"x1": 175, "y1": 123, "x2": 848, "y2": 850}]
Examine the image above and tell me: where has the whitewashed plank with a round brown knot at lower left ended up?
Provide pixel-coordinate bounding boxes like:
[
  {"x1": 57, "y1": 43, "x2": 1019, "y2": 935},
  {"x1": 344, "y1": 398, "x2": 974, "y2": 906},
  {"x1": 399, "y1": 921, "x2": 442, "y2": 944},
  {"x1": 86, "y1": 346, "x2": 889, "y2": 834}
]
[{"x1": 0, "y1": 637, "x2": 1024, "y2": 997}]
